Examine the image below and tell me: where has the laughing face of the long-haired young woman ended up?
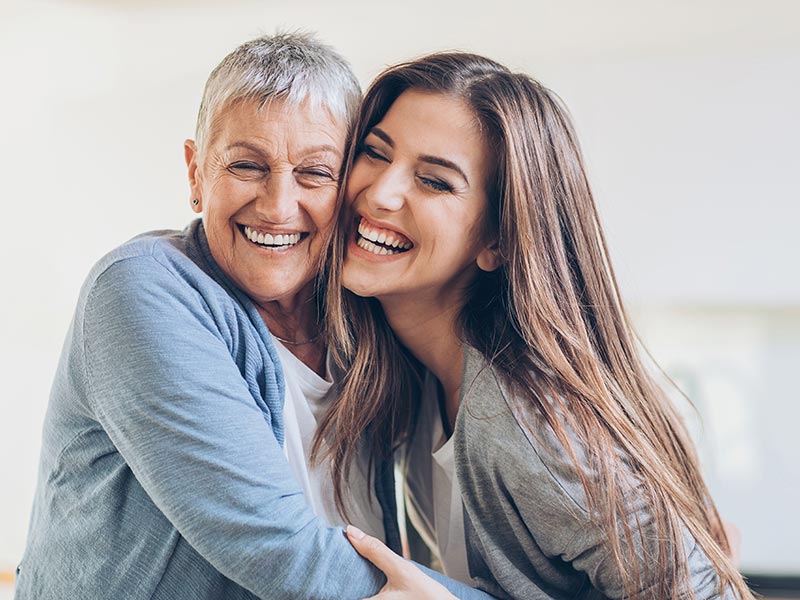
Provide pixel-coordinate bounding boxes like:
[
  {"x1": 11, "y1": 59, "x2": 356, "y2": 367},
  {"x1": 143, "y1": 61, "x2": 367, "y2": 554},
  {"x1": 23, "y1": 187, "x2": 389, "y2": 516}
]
[{"x1": 342, "y1": 90, "x2": 497, "y2": 309}]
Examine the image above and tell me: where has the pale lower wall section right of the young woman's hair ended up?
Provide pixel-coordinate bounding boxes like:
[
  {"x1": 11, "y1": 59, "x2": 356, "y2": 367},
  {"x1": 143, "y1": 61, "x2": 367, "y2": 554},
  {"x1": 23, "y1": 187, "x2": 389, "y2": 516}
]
[{"x1": 635, "y1": 305, "x2": 800, "y2": 575}]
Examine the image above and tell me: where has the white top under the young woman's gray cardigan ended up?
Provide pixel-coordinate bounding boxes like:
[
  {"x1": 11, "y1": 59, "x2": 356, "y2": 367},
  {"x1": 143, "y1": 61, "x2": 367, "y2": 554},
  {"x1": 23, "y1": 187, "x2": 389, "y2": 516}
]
[{"x1": 406, "y1": 373, "x2": 474, "y2": 586}]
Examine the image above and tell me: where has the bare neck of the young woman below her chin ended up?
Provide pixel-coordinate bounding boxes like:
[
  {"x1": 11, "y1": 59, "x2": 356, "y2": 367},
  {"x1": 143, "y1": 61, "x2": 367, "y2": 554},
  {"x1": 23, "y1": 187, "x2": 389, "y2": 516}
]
[{"x1": 381, "y1": 299, "x2": 464, "y2": 431}]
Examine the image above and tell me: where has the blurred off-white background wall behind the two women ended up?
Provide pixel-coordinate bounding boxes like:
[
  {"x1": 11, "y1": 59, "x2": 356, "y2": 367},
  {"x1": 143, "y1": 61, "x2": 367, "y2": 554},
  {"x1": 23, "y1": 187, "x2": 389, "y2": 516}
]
[{"x1": 0, "y1": 0, "x2": 800, "y2": 592}]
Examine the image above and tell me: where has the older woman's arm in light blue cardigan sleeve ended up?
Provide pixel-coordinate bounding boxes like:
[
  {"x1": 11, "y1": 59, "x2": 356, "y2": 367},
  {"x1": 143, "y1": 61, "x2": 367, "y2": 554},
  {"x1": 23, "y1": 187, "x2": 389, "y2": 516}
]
[{"x1": 83, "y1": 257, "x2": 384, "y2": 599}]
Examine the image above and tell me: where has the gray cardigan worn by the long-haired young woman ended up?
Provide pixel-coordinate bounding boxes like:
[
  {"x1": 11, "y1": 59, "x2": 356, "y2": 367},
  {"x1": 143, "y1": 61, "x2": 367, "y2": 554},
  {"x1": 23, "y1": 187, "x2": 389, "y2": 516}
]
[{"x1": 378, "y1": 346, "x2": 733, "y2": 599}]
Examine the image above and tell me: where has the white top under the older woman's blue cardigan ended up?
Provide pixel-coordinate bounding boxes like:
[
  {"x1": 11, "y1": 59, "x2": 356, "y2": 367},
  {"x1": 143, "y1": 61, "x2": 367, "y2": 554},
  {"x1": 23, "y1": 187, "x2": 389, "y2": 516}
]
[{"x1": 272, "y1": 336, "x2": 385, "y2": 540}]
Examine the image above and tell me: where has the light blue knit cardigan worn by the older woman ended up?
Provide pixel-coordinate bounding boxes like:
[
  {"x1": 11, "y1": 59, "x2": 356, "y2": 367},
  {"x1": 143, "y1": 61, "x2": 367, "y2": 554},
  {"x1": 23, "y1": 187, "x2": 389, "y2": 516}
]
[{"x1": 16, "y1": 221, "x2": 490, "y2": 600}]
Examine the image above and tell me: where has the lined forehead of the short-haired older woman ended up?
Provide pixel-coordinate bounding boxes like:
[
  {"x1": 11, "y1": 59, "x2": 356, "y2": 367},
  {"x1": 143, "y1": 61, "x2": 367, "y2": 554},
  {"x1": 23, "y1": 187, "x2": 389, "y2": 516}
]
[{"x1": 209, "y1": 98, "x2": 347, "y2": 154}]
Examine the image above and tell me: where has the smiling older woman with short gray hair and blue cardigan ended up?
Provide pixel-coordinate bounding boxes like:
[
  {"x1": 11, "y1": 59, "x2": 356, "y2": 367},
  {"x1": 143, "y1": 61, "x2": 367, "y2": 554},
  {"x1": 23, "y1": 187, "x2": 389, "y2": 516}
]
[{"x1": 16, "y1": 35, "x2": 490, "y2": 600}]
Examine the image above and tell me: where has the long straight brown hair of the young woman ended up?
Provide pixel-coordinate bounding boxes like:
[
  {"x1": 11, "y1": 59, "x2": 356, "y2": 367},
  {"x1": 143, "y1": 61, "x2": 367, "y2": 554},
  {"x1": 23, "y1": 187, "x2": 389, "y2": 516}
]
[{"x1": 314, "y1": 52, "x2": 752, "y2": 599}]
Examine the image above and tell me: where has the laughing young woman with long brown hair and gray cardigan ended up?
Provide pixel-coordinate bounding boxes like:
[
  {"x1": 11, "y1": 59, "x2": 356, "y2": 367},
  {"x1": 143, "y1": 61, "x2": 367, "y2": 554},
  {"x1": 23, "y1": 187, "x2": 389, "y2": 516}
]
[{"x1": 318, "y1": 53, "x2": 751, "y2": 599}]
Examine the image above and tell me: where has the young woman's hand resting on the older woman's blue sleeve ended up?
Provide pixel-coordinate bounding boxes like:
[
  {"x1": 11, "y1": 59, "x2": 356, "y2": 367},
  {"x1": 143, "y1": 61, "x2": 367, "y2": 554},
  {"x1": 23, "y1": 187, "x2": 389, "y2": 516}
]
[{"x1": 347, "y1": 525, "x2": 456, "y2": 600}]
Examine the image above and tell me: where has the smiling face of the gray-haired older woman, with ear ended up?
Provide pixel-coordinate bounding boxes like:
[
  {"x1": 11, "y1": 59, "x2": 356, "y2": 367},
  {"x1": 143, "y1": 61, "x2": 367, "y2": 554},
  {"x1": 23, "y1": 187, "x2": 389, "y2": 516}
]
[{"x1": 186, "y1": 100, "x2": 347, "y2": 305}]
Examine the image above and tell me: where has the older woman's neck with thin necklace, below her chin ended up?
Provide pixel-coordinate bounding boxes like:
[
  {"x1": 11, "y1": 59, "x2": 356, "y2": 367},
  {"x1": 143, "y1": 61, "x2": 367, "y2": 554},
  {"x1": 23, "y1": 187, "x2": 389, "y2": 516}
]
[{"x1": 256, "y1": 283, "x2": 326, "y2": 376}]
